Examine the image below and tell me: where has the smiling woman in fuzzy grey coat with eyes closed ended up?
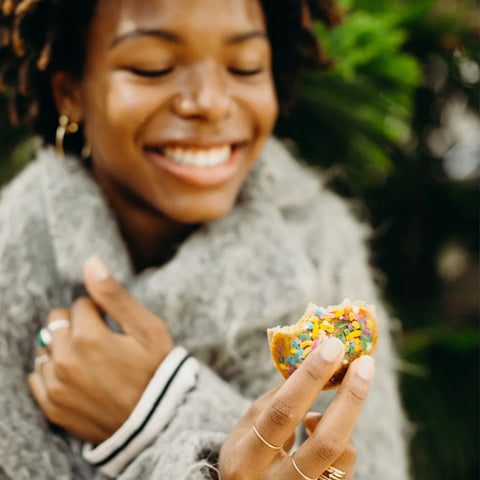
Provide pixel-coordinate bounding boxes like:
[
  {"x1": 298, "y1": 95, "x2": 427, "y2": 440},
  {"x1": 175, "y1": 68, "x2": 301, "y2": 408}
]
[{"x1": 0, "y1": 0, "x2": 407, "y2": 480}]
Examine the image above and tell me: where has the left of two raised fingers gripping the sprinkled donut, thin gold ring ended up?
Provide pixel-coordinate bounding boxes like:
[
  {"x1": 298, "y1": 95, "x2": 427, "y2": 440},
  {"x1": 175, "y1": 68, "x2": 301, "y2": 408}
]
[{"x1": 252, "y1": 338, "x2": 345, "y2": 465}]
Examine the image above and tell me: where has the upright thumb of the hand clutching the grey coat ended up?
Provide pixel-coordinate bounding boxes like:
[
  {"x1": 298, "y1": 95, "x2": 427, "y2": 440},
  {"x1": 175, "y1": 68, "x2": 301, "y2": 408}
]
[{"x1": 83, "y1": 255, "x2": 163, "y2": 339}]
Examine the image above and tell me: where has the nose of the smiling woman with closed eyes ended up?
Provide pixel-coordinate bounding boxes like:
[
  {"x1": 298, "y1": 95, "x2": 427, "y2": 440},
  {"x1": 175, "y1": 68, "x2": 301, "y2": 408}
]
[{"x1": 174, "y1": 62, "x2": 233, "y2": 122}]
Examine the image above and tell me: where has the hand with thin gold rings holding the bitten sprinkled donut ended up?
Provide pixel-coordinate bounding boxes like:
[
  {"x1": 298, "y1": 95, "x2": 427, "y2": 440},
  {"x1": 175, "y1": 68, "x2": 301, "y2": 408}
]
[{"x1": 219, "y1": 339, "x2": 374, "y2": 480}]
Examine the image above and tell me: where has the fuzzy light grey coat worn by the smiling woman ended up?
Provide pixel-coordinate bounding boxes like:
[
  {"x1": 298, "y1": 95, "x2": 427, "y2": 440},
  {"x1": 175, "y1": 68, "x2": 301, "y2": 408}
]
[{"x1": 0, "y1": 139, "x2": 408, "y2": 480}]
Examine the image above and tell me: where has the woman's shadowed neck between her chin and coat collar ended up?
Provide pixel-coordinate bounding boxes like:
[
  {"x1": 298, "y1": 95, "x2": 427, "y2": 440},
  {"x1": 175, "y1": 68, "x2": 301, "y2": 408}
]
[{"x1": 94, "y1": 172, "x2": 196, "y2": 272}]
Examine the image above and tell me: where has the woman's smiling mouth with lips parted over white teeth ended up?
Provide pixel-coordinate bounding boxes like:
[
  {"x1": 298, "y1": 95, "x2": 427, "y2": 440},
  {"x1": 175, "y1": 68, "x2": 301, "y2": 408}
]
[{"x1": 144, "y1": 143, "x2": 246, "y2": 187}]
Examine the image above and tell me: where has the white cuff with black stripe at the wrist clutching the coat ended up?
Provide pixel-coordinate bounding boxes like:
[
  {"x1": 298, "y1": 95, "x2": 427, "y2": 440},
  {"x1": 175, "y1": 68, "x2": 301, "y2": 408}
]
[{"x1": 82, "y1": 347, "x2": 198, "y2": 477}]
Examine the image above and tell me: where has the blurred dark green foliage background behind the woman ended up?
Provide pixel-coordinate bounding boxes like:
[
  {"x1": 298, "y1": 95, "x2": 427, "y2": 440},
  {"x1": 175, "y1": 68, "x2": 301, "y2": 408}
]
[{"x1": 0, "y1": 0, "x2": 480, "y2": 480}]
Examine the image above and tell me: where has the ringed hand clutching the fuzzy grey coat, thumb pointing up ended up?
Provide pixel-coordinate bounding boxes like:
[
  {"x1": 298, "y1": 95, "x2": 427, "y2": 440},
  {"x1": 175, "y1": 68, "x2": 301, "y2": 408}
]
[{"x1": 28, "y1": 257, "x2": 174, "y2": 444}]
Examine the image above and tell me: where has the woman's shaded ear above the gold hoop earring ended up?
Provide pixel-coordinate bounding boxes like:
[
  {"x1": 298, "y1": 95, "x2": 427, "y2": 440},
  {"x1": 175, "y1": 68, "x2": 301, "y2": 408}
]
[{"x1": 50, "y1": 72, "x2": 83, "y2": 123}]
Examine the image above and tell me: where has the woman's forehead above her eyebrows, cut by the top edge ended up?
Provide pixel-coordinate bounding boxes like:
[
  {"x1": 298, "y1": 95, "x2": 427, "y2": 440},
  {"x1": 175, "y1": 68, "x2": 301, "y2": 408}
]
[{"x1": 93, "y1": 0, "x2": 265, "y2": 40}]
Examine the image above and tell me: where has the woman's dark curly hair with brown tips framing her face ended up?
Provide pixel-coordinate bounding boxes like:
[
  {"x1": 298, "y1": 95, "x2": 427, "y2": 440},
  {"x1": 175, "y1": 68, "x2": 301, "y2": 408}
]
[{"x1": 0, "y1": 0, "x2": 343, "y2": 150}]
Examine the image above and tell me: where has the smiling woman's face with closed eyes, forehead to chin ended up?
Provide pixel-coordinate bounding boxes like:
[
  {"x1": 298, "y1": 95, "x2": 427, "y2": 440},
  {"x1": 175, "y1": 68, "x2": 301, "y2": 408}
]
[{"x1": 70, "y1": 0, "x2": 277, "y2": 223}]
